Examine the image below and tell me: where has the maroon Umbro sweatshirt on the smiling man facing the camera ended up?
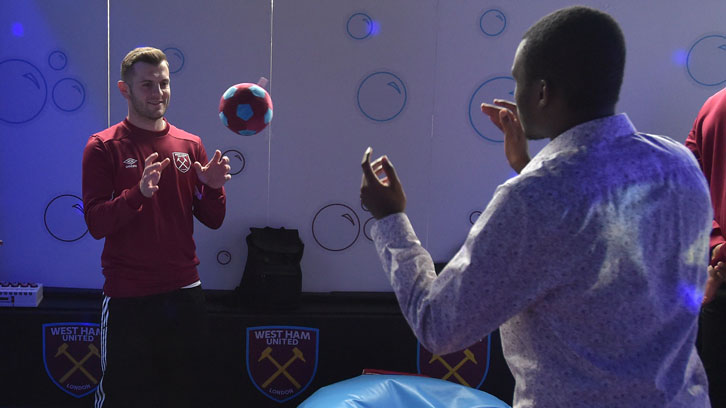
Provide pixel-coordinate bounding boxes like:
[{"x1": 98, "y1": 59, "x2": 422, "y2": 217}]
[{"x1": 83, "y1": 120, "x2": 226, "y2": 297}]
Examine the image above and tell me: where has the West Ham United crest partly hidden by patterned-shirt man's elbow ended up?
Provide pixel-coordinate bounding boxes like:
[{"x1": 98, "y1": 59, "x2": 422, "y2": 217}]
[{"x1": 418, "y1": 336, "x2": 491, "y2": 388}]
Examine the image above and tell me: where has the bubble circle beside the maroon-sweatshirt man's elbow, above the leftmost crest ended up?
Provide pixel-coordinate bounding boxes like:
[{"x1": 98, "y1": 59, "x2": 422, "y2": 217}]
[{"x1": 43, "y1": 194, "x2": 88, "y2": 242}]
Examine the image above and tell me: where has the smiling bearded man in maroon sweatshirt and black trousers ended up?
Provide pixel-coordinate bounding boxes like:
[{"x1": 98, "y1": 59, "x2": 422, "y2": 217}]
[{"x1": 83, "y1": 47, "x2": 231, "y2": 408}]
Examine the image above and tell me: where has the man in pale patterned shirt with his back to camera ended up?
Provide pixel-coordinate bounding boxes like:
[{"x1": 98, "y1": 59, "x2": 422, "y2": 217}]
[{"x1": 361, "y1": 7, "x2": 712, "y2": 408}]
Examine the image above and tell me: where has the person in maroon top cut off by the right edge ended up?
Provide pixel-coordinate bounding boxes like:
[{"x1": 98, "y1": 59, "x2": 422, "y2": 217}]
[{"x1": 686, "y1": 89, "x2": 726, "y2": 407}]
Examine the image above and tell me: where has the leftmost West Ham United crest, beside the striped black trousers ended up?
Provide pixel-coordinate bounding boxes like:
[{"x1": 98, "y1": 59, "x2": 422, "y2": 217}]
[{"x1": 43, "y1": 323, "x2": 101, "y2": 398}]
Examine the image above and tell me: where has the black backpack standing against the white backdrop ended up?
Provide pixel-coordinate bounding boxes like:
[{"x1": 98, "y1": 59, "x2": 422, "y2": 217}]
[{"x1": 238, "y1": 227, "x2": 305, "y2": 309}]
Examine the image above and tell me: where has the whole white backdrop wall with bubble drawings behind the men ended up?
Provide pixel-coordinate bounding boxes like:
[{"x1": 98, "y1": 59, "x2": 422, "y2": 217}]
[{"x1": 0, "y1": 0, "x2": 726, "y2": 291}]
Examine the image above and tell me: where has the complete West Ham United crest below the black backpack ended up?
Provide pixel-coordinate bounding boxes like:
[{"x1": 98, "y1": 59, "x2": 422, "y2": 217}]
[{"x1": 247, "y1": 326, "x2": 318, "y2": 402}]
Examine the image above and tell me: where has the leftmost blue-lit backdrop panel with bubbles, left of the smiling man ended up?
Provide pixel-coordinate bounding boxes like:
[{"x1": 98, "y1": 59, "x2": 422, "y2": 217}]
[{"x1": 0, "y1": 0, "x2": 107, "y2": 287}]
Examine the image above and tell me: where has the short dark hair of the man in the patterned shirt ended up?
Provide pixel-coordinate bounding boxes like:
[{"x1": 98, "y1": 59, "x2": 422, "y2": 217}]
[{"x1": 521, "y1": 6, "x2": 625, "y2": 111}]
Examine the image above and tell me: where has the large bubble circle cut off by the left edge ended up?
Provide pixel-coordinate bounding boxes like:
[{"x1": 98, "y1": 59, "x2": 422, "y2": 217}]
[{"x1": 0, "y1": 59, "x2": 48, "y2": 124}]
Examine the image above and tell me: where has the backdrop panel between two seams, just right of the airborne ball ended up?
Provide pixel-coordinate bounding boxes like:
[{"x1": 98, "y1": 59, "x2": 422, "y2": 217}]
[{"x1": 270, "y1": 0, "x2": 436, "y2": 291}]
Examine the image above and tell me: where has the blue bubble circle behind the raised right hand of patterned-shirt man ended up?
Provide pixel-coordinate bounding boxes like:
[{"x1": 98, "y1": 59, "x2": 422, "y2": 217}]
[{"x1": 469, "y1": 76, "x2": 515, "y2": 142}]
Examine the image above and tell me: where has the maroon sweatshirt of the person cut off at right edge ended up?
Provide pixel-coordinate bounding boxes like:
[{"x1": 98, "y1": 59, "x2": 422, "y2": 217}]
[{"x1": 686, "y1": 89, "x2": 726, "y2": 249}]
